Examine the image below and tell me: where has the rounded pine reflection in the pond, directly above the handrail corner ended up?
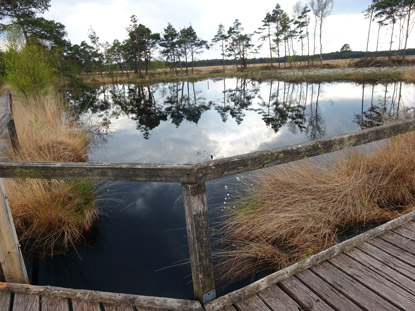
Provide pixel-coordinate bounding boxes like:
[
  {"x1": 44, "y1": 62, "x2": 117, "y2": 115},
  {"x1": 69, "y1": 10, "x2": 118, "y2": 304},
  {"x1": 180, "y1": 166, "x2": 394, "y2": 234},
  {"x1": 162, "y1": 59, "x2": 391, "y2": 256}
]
[{"x1": 164, "y1": 82, "x2": 211, "y2": 127}]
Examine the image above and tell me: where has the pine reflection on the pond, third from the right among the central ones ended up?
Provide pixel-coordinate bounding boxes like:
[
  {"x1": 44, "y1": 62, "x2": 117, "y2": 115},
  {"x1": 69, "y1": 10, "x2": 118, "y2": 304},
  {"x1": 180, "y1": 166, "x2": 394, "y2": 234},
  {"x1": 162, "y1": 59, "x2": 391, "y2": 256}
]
[{"x1": 215, "y1": 78, "x2": 259, "y2": 125}]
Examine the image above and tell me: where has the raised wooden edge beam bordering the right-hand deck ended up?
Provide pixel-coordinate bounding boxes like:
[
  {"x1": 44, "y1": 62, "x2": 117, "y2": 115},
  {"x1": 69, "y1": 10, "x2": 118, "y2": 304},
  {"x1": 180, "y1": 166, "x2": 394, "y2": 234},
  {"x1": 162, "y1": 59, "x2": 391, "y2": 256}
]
[{"x1": 205, "y1": 211, "x2": 415, "y2": 311}]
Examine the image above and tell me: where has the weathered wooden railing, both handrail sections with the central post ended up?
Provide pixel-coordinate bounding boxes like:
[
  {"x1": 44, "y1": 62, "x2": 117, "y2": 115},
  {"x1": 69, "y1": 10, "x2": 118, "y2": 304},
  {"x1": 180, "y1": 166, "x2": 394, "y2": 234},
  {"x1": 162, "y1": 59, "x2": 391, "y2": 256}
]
[{"x1": 0, "y1": 91, "x2": 415, "y2": 304}]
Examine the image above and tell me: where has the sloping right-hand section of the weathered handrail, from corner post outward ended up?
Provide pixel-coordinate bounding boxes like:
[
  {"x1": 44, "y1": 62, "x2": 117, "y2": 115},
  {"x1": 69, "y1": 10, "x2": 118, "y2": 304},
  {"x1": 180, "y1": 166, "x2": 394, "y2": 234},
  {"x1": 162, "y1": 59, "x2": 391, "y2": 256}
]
[{"x1": 198, "y1": 121, "x2": 415, "y2": 181}]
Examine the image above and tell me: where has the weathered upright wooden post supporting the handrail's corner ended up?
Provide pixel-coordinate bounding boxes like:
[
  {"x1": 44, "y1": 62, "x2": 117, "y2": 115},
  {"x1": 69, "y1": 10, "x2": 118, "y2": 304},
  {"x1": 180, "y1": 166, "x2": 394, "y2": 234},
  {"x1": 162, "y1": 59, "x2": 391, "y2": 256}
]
[{"x1": 182, "y1": 183, "x2": 216, "y2": 304}]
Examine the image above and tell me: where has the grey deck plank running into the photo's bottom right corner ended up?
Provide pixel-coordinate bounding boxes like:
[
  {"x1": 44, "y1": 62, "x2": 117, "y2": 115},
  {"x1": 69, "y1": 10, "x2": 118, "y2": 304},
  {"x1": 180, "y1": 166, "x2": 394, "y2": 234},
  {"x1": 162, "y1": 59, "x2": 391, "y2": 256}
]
[{"x1": 329, "y1": 254, "x2": 415, "y2": 310}]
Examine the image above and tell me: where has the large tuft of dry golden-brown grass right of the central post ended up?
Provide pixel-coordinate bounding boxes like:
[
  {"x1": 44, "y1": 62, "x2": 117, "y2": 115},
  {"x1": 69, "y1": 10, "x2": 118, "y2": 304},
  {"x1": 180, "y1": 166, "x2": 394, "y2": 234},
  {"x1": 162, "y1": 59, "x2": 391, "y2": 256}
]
[{"x1": 217, "y1": 133, "x2": 415, "y2": 281}]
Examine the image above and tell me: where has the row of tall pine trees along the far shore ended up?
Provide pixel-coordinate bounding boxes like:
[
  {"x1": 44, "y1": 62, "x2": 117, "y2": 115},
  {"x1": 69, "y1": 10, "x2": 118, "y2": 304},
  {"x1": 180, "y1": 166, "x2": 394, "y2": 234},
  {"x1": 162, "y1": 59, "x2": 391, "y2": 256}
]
[{"x1": 0, "y1": 0, "x2": 415, "y2": 86}]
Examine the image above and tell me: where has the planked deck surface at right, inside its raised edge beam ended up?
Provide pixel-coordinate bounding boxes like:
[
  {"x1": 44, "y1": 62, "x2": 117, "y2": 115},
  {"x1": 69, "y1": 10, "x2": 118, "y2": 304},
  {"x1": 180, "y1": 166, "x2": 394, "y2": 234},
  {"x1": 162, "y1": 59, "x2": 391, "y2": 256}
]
[{"x1": 207, "y1": 214, "x2": 415, "y2": 311}]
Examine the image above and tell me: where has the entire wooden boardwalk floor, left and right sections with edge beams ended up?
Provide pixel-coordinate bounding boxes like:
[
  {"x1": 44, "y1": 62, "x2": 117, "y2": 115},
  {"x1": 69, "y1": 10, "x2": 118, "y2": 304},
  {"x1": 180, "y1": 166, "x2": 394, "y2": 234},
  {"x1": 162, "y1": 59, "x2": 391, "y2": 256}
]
[{"x1": 0, "y1": 212, "x2": 415, "y2": 311}]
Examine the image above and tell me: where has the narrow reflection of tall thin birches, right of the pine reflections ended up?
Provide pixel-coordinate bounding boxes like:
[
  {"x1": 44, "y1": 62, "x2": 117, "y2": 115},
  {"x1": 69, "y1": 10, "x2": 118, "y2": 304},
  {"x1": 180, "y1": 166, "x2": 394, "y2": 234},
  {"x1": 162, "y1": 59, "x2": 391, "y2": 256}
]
[{"x1": 305, "y1": 83, "x2": 326, "y2": 140}]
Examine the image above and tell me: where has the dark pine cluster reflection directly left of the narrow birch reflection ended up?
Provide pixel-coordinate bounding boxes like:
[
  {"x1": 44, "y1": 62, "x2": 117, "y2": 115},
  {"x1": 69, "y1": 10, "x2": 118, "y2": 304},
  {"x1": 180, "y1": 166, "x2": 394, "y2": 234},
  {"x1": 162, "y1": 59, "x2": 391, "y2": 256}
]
[{"x1": 258, "y1": 81, "x2": 307, "y2": 133}]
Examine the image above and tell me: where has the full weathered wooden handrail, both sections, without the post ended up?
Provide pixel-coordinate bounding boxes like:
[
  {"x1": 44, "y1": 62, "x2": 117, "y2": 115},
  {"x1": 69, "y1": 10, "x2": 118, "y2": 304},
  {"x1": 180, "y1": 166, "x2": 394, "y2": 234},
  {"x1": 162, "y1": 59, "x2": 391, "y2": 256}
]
[{"x1": 0, "y1": 120, "x2": 415, "y2": 184}]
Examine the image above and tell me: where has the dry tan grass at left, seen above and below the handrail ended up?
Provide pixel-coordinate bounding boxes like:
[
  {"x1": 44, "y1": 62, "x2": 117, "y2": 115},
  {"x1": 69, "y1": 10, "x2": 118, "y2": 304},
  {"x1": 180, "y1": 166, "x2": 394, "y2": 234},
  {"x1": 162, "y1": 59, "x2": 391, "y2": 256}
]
[{"x1": 5, "y1": 95, "x2": 98, "y2": 256}]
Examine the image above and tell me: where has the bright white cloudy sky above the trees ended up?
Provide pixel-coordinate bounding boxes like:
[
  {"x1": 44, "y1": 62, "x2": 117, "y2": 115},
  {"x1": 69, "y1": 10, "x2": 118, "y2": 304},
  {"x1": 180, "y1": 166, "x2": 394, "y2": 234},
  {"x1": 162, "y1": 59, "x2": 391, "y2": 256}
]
[{"x1": 36, "y1": 0, "x2": 415, "y2": 59}]
